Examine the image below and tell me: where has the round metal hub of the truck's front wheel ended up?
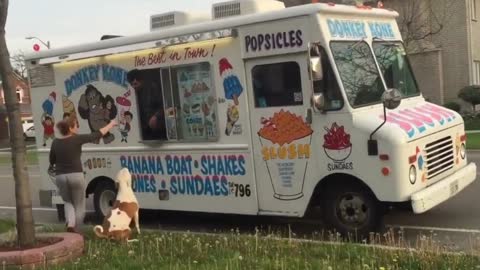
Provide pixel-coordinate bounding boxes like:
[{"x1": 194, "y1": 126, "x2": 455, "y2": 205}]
[{"x1": 337, "y1": 194, "x2": 368, "y2": 227}]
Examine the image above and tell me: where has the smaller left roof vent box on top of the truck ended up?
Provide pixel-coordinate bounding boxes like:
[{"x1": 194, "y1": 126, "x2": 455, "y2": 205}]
[{"x1": 150, "y1": 11, "x2": 211, "y2": 31}]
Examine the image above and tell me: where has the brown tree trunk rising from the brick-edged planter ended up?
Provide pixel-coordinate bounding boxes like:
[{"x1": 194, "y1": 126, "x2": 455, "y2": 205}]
[{"x1": 0, "y1": 0, "x2": 35, "y2": 247}]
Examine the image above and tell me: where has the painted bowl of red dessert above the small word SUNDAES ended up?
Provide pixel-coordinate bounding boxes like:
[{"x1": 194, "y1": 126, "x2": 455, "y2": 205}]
[{"x1": 323, "y1": 123, "x2": 352, "y2": 162}]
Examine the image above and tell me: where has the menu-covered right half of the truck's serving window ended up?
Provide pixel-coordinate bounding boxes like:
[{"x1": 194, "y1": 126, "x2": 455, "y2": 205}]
[{"x1": 162, "y1": 62, "x2": 218, "y2": 141}]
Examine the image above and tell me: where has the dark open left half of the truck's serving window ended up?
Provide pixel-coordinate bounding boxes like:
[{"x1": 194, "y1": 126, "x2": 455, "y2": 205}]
[{"x1": 127, "y1": 68, "x2": 167, "y2": 141}]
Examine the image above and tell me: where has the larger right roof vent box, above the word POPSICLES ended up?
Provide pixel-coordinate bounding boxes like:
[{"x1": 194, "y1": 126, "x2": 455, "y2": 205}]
[{"x1": 212, "y1": 0, "x2": 285, "y2": 20}]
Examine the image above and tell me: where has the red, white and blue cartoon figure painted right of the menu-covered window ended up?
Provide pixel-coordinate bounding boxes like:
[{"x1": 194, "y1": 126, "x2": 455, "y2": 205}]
[{"x1": 219, "y1": 58, "x2": 243, "y2": 136}]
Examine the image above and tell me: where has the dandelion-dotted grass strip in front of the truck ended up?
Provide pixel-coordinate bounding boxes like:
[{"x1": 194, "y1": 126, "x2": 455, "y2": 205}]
[{"x1": 39, "y1": 227, "x2": 480, "y2": 270}]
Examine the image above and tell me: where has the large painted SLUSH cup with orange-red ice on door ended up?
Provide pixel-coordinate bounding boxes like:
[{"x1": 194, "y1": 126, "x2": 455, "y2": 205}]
[{"x1": 258, "y1": 110, "x2": 313, "y2": 200}]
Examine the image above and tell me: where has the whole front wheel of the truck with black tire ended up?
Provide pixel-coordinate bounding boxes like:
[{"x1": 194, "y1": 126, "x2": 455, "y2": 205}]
[{"x1": 322, "y1": 183, "x2": 383, "y2": 239}]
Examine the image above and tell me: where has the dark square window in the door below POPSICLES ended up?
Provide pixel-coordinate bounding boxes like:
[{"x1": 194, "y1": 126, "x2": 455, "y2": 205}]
[{"x1": 252, "y1": 62, "x2": 303, "y2": 108}]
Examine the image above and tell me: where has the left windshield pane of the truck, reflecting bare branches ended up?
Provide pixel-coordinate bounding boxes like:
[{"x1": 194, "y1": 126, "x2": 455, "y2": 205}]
[{"x1": 330, "y1": 41, "x2": 385, "y2": 108}]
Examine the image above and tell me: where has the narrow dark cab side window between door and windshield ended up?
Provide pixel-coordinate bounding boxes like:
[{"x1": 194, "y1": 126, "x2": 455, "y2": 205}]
[{"x1": 311, "y1": 46, "x2": 343, "y2": 111}]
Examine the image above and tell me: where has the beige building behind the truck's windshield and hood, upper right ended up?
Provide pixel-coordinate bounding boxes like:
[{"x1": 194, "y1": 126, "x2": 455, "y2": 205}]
[{"x1": 283, "y1": 0, "x2": 480, "y2": 104}]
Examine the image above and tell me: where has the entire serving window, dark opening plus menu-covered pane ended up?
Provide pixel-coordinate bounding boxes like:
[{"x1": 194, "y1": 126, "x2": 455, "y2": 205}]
[{"x1": 127, "y1": 63, "x2": 218, "y2": 141}]
